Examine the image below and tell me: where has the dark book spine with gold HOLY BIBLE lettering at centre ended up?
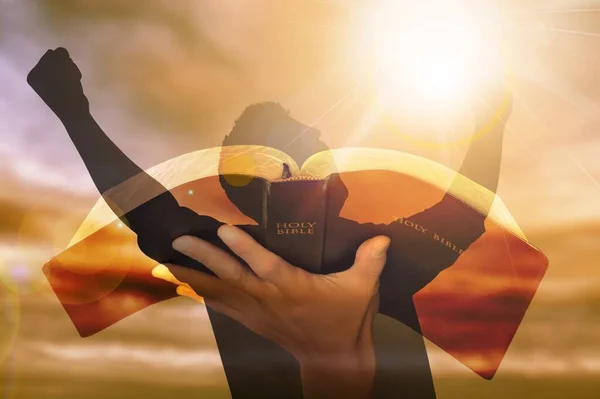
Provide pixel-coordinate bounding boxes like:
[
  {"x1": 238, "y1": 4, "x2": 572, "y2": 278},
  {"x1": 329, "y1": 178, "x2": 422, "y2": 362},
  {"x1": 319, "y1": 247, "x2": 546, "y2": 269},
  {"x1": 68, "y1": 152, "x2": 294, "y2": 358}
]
[{"x1": 263, "y1": 180, "x2": 327, "y2": 273}]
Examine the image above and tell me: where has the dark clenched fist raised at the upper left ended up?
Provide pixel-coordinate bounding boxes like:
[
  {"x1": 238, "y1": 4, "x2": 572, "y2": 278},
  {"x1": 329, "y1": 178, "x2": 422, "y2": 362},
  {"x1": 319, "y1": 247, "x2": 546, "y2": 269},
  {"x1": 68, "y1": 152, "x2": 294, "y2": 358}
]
[{"x1": 27, "y1": 47, "x2": 89, "y2": 117}]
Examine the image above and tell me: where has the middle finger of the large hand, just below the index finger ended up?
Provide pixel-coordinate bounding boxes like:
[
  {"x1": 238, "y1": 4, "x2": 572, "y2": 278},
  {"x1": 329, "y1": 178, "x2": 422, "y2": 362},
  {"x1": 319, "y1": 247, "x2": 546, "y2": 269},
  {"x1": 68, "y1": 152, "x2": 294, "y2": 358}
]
[{"x1": 173, "y1": 236, "x2": 260, "y2": 293}]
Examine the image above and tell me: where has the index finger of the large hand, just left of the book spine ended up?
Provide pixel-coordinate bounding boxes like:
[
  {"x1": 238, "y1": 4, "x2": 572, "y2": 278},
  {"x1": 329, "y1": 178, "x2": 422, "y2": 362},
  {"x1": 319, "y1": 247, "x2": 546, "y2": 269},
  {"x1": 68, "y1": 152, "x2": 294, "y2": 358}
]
[{"x1": 217, "y1": 225, "x2": 300, "y2": 288}]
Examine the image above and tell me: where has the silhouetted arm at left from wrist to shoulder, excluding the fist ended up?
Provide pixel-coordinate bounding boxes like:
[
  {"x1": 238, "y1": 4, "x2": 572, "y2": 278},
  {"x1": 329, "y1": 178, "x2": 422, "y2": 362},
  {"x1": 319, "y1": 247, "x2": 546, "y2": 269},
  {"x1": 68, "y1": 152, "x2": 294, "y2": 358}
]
[{"x1": 60, "y1": 106, "x2": 225, "y2": 268}]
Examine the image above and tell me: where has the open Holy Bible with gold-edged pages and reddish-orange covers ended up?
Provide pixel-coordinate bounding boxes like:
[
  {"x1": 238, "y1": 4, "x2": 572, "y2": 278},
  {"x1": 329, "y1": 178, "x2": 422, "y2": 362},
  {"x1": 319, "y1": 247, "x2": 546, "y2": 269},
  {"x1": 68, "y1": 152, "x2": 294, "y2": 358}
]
[{"x1": 44, "y1": 146, "x2": 548, "y2": 378}]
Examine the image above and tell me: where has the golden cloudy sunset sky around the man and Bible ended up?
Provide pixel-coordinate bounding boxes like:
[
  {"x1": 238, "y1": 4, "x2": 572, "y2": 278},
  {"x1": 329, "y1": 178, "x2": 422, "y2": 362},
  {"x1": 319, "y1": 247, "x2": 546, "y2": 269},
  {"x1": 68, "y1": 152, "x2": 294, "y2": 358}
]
[{"x1": 0, "y1": 0, "x2": 600, "y2": 399}]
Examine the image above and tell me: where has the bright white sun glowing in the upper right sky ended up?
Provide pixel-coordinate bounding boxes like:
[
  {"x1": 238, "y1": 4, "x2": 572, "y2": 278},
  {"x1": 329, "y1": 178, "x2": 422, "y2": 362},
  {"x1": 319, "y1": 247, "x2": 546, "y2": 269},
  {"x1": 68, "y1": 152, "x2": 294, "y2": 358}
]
[{"x1": 372, "y1": 0, "x2": 501, "y2": 107}]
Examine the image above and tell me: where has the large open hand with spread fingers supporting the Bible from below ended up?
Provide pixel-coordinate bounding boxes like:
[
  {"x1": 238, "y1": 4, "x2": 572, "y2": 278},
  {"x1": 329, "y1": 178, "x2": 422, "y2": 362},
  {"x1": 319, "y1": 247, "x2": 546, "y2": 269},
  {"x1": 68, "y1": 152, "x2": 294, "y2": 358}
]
[{"x1": 153, "y1": 226, "x2": 390, "y2": 398}]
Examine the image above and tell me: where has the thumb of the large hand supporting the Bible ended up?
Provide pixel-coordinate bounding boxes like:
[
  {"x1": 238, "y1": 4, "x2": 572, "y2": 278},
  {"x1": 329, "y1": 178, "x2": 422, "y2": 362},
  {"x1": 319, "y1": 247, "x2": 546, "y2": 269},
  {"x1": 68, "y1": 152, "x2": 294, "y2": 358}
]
[{"x1": 348, "y1": 236, "x2": 390, "y2": 285}]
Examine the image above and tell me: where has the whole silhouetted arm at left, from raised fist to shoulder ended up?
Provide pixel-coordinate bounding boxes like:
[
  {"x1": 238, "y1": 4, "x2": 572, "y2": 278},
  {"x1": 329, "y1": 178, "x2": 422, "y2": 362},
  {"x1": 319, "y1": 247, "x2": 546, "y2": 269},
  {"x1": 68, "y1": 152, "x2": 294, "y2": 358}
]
[{"x1": 27, "y1": 47, "x2": 227, "y2": 271}]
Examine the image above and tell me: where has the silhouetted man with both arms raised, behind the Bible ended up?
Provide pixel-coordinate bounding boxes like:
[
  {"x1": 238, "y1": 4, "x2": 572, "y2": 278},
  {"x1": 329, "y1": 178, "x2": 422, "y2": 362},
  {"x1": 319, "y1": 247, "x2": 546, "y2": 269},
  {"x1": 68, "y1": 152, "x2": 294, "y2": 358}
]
[{"x1": 28, "y1": 48, "x2": 511, "y2": 399}]
